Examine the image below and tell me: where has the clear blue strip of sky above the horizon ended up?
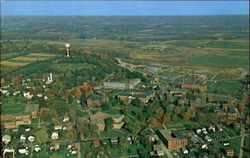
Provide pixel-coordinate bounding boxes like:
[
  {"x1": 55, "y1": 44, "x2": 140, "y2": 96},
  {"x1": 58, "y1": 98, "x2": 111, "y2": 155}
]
[{"x1": 1, "y1": 0, "x2": 249, "y2": 16}]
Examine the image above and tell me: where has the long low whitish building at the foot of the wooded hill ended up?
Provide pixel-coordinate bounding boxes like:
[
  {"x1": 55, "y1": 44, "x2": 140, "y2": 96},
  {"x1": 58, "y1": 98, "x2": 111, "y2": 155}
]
[{"x1": 103, "y1": 79, "x2": 141, "y2": 89}]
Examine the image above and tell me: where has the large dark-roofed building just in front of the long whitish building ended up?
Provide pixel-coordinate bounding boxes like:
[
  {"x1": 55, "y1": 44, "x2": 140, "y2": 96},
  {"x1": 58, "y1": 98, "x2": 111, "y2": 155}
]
[{"x1": 117, "y1": 89, "x2": 155, "y2": 104}]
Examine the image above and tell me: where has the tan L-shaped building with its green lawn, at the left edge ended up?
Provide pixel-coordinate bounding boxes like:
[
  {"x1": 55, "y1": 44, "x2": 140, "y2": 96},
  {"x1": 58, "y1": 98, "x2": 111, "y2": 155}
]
[{"x1": 1, "y1": 102, "x2": 39, "y2": 128}]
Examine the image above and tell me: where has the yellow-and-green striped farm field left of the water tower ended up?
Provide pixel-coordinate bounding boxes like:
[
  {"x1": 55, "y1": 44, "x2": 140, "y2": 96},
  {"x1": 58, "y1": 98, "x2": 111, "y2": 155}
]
[{"x1": 1, "y1": 53, "x2": 56, "y2": 67}]
